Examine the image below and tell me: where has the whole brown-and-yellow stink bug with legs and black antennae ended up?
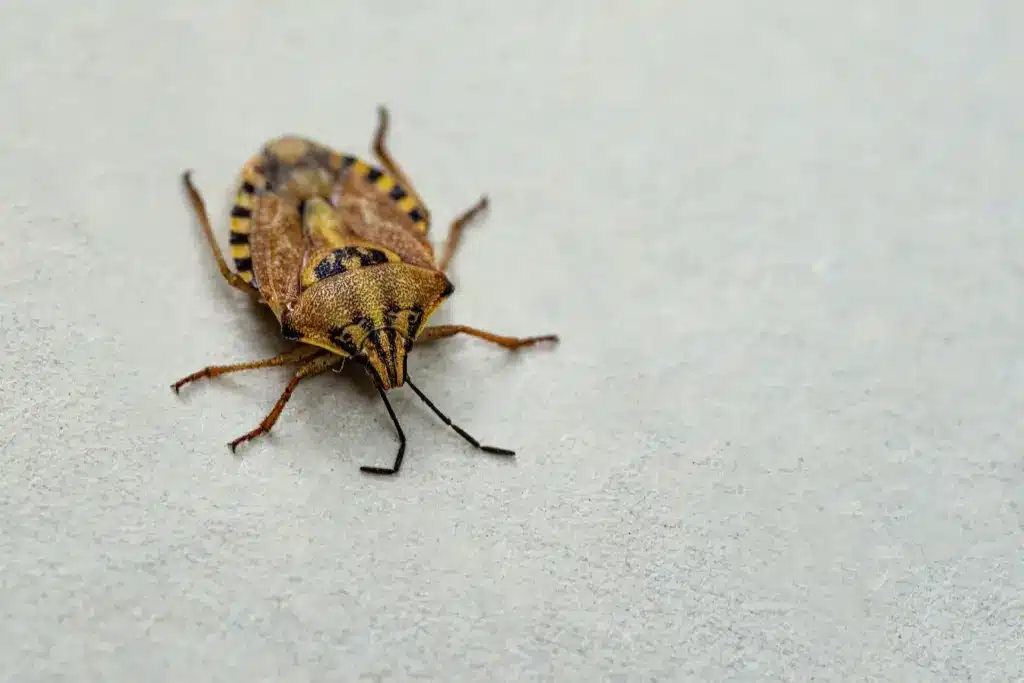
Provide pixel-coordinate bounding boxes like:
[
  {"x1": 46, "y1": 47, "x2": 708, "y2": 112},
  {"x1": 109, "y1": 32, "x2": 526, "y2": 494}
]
[{"x1": 171, "y1": 106, "x2": 558, "y2": 474}]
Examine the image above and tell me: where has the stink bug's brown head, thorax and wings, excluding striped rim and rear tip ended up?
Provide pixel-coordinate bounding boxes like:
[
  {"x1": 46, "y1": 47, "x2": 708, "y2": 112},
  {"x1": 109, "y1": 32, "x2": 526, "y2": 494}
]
[{"x1": 243, "y1": 169, "x2": 455, "y2": 389}]
